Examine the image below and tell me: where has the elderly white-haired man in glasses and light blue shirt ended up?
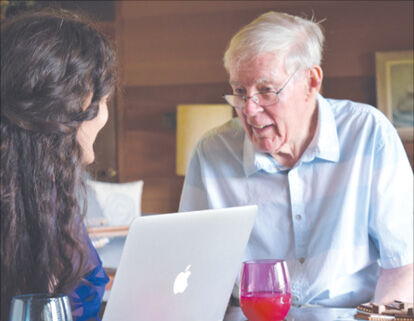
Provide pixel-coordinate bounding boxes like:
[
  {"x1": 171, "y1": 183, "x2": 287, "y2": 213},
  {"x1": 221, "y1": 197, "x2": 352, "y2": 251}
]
[{"x1": 180, "y1": 12, "x2": 413, "y2": 307}]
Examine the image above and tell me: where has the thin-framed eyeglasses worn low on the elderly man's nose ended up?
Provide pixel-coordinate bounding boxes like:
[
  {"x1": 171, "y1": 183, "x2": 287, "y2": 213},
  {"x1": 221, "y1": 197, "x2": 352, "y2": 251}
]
[{"x1": 223, "y1": 69, "x2": 298, "y2": 109}]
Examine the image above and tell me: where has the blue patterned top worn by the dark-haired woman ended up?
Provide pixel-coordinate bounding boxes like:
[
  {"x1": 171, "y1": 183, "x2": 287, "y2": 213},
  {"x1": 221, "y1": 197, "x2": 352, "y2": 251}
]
[{"x1": 68, "y1": 231, "x2": 109, "y2": 321}]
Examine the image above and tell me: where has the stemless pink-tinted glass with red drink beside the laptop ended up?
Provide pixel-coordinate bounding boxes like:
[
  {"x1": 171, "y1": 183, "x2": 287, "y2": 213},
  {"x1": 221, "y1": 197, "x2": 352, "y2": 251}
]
[{"x1": 240, "y1": 260, "x2": 292, "y2": 321}]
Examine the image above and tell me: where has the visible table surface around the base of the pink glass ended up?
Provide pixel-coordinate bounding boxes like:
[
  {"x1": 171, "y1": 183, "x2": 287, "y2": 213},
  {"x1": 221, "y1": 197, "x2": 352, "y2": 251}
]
[{"x1": 223, "y1": 307, "x2": 356, "y2": 321}]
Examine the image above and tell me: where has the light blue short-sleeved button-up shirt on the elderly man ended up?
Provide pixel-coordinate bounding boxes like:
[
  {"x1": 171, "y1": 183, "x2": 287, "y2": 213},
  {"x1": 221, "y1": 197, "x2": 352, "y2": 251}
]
[{"x1": 180, "y1": 96, "x2": 413, "y2": 307}]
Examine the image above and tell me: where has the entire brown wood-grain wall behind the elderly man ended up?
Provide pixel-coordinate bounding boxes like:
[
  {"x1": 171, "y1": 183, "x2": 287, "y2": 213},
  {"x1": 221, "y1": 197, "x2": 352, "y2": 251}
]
[{"x1": 111, "y1": 1, "x2": 414, "y2": 213}]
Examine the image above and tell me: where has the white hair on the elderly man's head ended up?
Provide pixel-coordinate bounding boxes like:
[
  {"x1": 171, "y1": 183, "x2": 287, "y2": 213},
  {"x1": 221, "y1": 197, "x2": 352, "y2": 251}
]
[{"x1": 223, "y1": 11, "x2": 324, "y2": 72}]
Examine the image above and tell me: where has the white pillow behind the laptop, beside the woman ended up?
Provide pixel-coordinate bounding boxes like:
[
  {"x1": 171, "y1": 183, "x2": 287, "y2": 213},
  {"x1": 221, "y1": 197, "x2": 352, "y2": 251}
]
[{"x1": 86, "y1": 179, "x2": 144, "y2": 226}]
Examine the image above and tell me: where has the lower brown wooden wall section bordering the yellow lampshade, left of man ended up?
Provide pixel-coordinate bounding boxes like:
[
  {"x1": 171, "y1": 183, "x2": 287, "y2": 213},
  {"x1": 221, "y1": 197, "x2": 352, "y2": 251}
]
[{"x1": 119, "y1": 83, "x2": 229, "y2": 213}]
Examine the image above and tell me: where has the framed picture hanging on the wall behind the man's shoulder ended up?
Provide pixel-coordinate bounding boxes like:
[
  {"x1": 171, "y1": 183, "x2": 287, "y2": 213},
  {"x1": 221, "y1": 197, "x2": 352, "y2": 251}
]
[{"x1": 375, "y1": 50, "x2": 414, "y2": 140}]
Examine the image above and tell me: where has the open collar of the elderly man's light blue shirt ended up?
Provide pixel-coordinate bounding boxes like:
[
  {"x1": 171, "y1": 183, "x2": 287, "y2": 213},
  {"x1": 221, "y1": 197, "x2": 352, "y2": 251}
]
[{"x1": 243, "y1": 94, "x2": 339, "y2": 176}]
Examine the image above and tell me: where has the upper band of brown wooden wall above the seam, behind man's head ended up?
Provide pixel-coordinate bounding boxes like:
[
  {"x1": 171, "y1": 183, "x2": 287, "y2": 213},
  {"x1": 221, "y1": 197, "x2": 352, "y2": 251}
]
[{"x1": 120, "y1": 1, "x2": 413, "y2": 86}]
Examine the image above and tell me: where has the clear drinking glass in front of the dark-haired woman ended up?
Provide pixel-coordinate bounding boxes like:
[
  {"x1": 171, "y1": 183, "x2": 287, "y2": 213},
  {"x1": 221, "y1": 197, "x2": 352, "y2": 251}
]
[{"x1": 9, "y1": 294, "x2": 72, "y2": 321}]
